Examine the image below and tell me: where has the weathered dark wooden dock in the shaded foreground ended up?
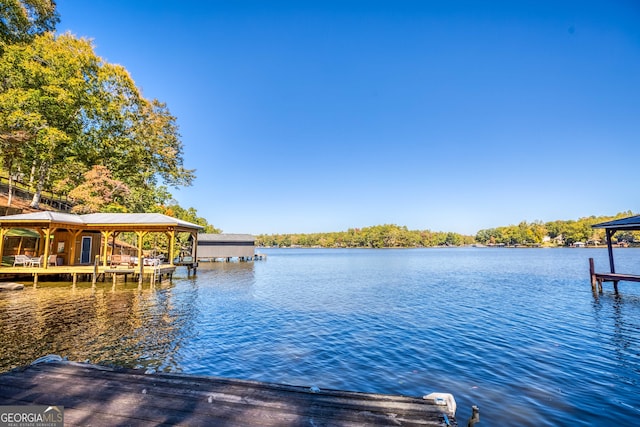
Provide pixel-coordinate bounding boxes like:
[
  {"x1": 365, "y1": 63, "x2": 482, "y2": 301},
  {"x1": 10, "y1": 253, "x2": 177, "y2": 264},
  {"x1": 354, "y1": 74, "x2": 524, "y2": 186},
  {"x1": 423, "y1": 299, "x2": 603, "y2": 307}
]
[{"x1": 0, "y1": 361, "x2": 458, "y2": 427}]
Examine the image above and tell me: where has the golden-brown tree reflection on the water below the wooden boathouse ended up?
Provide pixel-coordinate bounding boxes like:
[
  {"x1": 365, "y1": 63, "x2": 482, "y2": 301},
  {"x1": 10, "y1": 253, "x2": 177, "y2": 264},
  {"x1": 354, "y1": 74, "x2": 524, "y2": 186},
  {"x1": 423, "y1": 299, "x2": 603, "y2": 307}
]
[{"x1": 0, "y1": 280, "x2": 197, "y2": 371}]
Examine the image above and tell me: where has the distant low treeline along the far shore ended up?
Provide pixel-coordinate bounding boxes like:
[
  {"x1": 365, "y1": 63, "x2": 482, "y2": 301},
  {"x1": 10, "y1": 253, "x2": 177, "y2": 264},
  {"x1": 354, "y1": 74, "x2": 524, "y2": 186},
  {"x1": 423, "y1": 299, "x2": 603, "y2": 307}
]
[{"x1": 256, "y1": 211, "x2": 640, "y2": 248}]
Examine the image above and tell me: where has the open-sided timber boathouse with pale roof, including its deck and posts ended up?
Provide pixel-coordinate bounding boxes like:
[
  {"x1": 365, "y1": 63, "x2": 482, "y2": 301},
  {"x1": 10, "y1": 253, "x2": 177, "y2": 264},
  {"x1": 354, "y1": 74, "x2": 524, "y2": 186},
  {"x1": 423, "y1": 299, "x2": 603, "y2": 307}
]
[{"x1": 0, "y1": 211, "x2": 202, "y2": 283}]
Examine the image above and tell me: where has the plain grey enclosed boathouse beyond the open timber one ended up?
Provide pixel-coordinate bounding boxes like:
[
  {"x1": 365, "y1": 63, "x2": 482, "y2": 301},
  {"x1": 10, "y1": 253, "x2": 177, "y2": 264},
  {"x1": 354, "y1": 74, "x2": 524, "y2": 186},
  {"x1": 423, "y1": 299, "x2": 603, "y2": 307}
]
[{"x1": 197, "y1": 233, "x2": 256, "y2": 261}]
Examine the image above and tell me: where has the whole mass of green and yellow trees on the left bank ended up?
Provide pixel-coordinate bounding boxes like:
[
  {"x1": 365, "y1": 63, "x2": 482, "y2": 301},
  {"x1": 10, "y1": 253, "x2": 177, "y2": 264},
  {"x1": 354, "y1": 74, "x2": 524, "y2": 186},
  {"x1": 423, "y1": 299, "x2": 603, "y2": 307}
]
[{"x1": 0, "y1": 0, "x2": 215, "y2": 232}]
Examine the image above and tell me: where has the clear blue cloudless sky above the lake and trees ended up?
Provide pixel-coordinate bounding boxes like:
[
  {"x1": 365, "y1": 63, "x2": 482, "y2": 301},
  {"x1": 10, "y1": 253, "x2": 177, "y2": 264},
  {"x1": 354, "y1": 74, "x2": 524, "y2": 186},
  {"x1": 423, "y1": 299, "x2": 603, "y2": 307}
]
[{"x1": 57, "y1": 0, "x2": 640, "y2": 234}]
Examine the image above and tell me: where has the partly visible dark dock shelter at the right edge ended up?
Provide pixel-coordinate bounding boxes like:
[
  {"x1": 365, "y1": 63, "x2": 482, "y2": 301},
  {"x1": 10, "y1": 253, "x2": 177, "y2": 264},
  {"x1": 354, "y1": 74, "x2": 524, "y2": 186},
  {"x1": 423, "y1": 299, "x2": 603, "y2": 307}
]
[{"x1": 589, "y1": 215, "x2": 640, "y2": 293}]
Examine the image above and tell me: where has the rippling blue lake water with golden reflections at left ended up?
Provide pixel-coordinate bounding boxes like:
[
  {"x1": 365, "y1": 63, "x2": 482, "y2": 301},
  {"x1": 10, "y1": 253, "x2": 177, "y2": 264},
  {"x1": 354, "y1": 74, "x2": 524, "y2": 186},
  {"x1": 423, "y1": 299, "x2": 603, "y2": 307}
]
[{"x1": 0, "y1": 248, "x2": 640, "y2": 426}]
